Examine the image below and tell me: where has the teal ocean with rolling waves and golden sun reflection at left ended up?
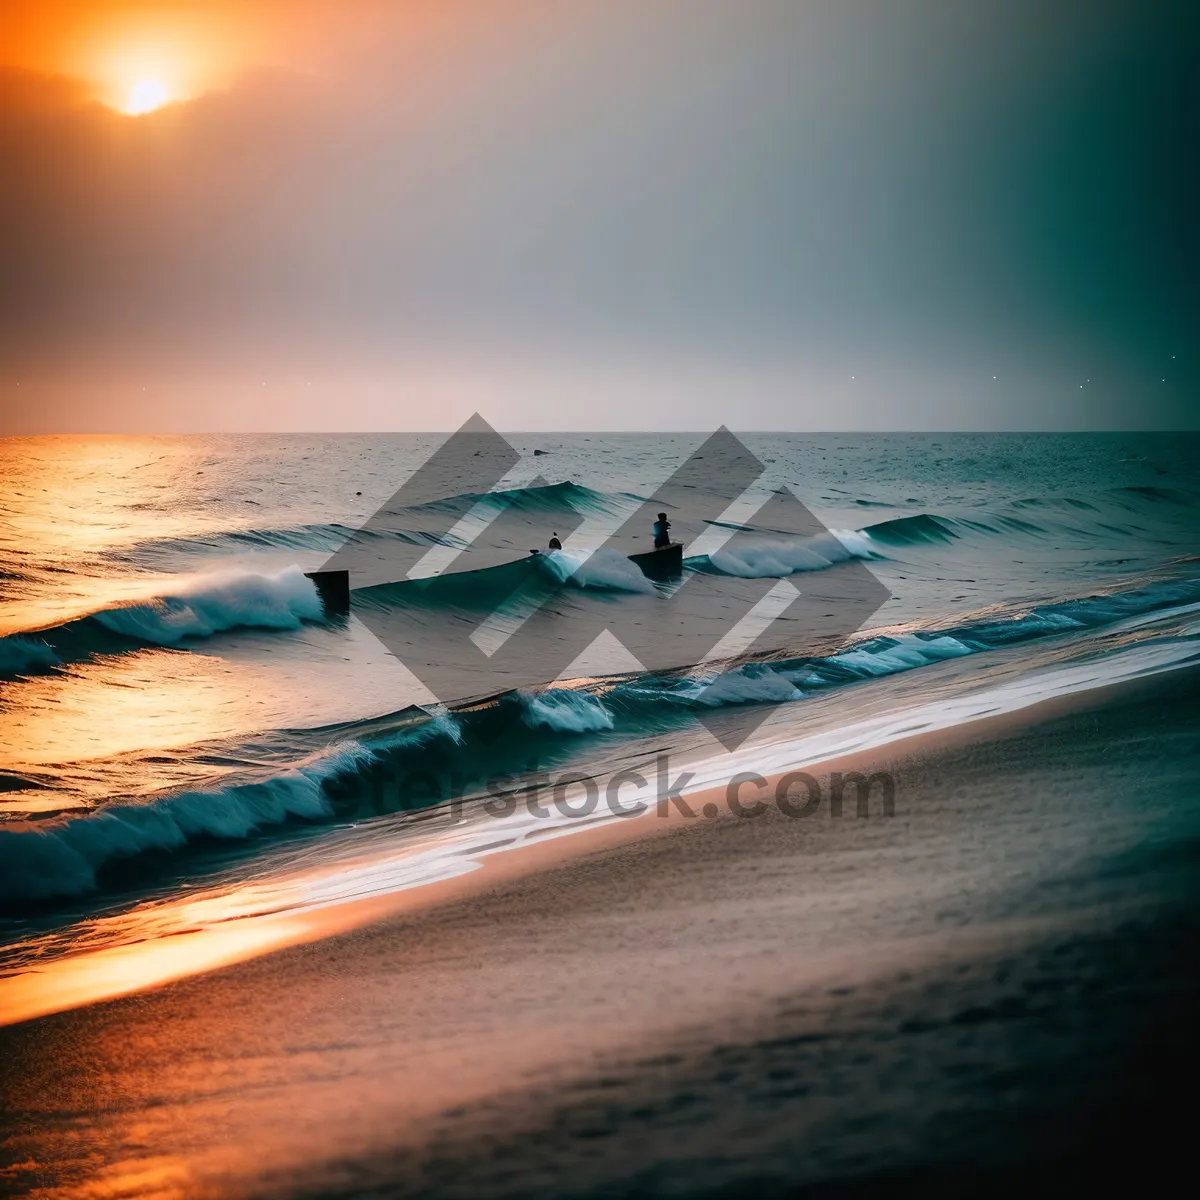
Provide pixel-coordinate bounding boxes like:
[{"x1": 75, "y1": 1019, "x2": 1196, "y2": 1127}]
[{"x1": 0, "y1": 433, "x2": 1200, "y2": 1020}]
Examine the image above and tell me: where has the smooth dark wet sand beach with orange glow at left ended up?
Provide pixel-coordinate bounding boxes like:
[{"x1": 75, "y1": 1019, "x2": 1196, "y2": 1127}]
[{"x1": 0, "y1": 671, "x2": 1200, "y2": 1196}]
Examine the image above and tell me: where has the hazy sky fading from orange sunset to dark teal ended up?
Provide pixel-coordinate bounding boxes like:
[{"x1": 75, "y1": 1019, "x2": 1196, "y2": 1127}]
[{"x1": 0, "y1": 0, "x2": 1200, "y2": 432}]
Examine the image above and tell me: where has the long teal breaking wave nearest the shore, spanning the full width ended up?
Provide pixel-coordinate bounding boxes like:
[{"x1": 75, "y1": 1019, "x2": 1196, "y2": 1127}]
[{"x1": 0, "y1": 578, "x2": 1200, "y2": 910}]
